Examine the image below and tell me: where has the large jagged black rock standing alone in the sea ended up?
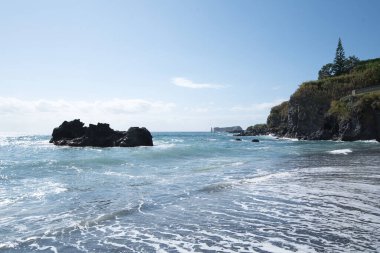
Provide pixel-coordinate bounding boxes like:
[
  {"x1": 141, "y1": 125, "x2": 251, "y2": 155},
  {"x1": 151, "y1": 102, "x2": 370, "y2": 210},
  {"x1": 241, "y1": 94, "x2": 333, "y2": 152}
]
[{"x1": 50, "y1": 119, "x2": 153, "y2": 147}]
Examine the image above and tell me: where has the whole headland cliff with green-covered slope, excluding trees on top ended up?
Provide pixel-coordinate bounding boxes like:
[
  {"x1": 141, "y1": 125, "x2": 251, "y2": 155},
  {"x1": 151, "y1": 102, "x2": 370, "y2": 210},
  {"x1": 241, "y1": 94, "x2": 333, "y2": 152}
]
[{"x1": 248, "y1": 58, "x2": 380, "y2": 141}]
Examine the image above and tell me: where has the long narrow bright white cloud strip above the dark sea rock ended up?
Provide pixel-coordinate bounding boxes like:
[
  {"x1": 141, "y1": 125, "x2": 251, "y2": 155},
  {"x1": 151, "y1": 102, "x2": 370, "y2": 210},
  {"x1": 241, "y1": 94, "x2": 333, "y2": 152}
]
[{"x1": 0, "y1": 97, "x2": 175, "y2": 114}]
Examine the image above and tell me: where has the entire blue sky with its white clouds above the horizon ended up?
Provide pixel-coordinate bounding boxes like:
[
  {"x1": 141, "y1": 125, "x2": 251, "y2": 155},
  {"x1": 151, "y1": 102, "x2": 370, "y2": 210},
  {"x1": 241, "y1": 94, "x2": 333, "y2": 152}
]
[{"x1": 0, "y1": 0, "x2": 380, "y2": 134}]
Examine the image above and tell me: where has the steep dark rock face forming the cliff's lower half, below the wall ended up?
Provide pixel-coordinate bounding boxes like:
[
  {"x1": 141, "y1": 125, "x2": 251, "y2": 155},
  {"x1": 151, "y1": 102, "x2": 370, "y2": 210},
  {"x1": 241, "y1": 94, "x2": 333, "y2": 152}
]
[{"x1": 267, "y1": 93, "x2": 380, "y2": 141}]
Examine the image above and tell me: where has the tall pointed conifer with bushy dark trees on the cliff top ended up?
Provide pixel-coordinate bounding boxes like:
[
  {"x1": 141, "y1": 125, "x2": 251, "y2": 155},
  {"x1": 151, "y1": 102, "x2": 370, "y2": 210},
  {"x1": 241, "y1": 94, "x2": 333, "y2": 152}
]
[{"x1": 318, "y1": 38, "x2": 359, "y2": 80}]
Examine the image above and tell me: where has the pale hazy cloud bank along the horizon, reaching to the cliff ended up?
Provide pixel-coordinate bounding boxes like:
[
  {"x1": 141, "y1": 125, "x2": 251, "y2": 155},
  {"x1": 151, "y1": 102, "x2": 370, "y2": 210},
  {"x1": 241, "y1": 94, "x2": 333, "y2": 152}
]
[{"x1": 0, "y1": 97, "x2": 283, "y2": 135}]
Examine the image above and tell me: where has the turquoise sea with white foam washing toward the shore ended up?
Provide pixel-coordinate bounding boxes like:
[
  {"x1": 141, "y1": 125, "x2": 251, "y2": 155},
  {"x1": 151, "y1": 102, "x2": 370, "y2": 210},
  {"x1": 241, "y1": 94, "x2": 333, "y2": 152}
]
[{"x1": 0, "y1": 133, "x2": 380, "y2": 252}]
